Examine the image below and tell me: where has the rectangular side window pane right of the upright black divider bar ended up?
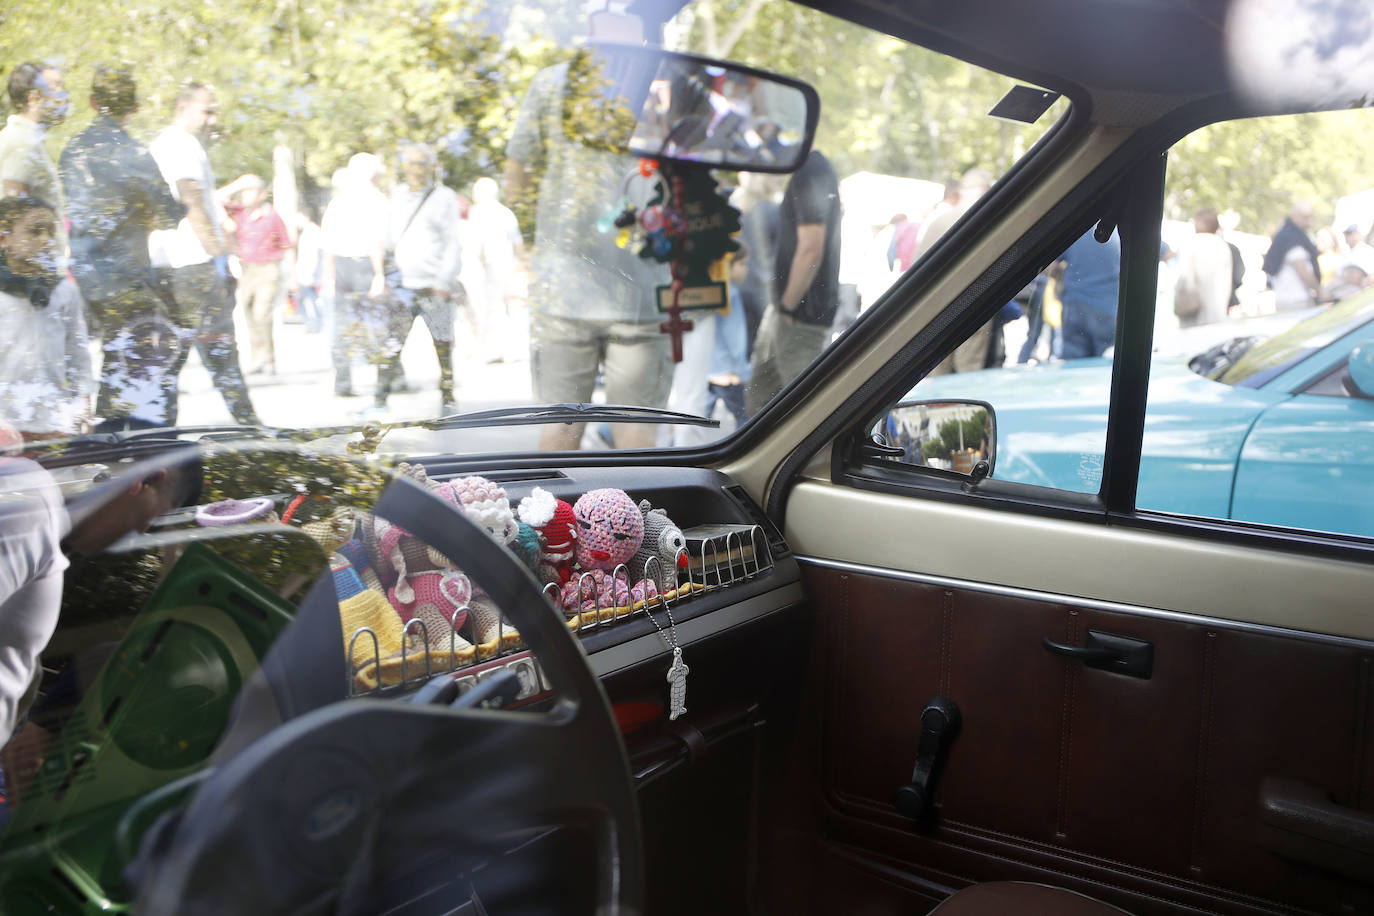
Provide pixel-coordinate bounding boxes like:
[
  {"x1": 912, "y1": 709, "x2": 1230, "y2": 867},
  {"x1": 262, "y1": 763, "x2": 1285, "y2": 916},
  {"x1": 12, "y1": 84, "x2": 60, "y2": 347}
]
[{"x1": 1136, "y1": 111, "x2": 1374, "y2": 536}]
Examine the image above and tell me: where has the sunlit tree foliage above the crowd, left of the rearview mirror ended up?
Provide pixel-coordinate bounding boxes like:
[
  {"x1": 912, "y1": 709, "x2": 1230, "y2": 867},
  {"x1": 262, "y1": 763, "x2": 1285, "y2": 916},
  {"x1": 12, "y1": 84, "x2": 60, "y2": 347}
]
[{"x1": 0, "y1": 0, "x2": 558, "y2": 197}]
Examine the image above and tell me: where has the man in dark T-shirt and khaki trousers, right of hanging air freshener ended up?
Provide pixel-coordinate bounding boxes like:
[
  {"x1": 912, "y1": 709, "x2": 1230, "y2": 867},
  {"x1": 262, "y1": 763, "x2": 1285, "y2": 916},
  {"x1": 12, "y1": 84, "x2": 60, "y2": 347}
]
[{"x1": 746, "y1": 150, "x2": 841, "y2": 416}]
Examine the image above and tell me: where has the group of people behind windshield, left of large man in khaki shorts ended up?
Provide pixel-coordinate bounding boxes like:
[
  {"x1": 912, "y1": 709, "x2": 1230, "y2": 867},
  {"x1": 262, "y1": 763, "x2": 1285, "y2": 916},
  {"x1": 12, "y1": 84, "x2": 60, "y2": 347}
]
[{"x1": 0, "y1": 63, "x2": 521, "y2": 439}]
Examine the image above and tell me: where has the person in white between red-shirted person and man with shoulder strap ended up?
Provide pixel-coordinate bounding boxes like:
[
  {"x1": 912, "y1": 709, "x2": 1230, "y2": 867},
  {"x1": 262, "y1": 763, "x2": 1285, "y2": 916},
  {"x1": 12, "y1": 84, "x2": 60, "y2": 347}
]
[{"x1": 320, "y1": 152, "x2": 390, "y2": 397}]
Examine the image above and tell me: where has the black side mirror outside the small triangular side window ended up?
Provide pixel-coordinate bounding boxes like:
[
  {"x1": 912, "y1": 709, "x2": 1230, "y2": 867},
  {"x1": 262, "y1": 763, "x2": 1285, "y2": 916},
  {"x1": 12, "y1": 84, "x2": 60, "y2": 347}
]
[{"x1": 872, "y1": 401, "x2": 998, "y2": 482}]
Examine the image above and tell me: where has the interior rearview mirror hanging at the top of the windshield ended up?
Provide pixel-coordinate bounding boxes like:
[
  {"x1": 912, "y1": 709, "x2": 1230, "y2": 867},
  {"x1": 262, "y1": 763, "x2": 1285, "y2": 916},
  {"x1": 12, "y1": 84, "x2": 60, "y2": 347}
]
[{"x1": 577, "y1": 43, "x2": 820, "y2": 172}]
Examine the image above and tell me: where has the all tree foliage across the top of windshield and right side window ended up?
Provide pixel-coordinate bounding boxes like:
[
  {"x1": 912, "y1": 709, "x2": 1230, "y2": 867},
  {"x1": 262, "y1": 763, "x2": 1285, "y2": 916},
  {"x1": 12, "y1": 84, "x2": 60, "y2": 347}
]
[{"x1": 0, "y1": 0, "x2": 1374, "y2": 233}]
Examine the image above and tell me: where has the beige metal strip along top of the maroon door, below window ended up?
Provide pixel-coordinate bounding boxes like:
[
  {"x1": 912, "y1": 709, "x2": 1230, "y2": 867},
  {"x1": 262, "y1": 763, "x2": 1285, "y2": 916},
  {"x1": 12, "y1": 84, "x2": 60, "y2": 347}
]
[{"x1": 785, "y1": 479, "x2": 1374, "y2": 640}]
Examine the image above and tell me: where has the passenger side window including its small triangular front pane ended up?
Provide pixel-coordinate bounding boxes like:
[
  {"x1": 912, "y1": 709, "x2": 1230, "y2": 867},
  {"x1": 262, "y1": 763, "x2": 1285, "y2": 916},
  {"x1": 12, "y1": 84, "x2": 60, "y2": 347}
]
[{"x1": 874, "y1": 111, "x2": 1374, "y2": 536}]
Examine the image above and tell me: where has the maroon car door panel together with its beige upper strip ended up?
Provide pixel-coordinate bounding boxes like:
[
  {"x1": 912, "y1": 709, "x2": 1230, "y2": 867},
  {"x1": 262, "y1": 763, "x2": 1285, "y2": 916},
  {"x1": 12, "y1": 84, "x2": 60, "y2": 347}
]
[{"x1": 763, "y1": 482, "x2": 1374, "y2": 913}]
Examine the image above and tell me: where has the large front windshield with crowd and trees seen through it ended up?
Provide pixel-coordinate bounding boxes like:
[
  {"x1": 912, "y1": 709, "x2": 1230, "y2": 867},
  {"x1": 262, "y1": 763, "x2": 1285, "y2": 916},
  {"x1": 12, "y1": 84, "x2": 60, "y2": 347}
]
[{"x1": 0, "y1": 0, "x2": 1068, "y2": 453}]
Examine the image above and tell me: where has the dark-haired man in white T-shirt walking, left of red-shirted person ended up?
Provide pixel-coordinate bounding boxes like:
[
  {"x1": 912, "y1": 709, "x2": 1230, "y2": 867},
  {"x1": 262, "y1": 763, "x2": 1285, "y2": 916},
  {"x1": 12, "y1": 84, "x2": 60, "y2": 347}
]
[{"x1": 148, "y1": 82, "x2": 260, "y2": 426}]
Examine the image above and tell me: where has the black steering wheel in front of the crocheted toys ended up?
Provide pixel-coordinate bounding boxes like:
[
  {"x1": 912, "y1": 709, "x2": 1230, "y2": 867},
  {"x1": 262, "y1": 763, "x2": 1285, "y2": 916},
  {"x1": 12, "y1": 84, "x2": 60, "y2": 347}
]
[{"x1": 135, "y1": 478, "x2": 644, "y2": 916}]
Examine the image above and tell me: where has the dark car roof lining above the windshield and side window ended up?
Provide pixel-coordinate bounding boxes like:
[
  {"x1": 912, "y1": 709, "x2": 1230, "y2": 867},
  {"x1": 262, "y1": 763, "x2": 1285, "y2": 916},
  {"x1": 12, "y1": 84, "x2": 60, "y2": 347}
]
[{"x1": 629, "y1": 0, "x2": 1374, "y2": 126}]
